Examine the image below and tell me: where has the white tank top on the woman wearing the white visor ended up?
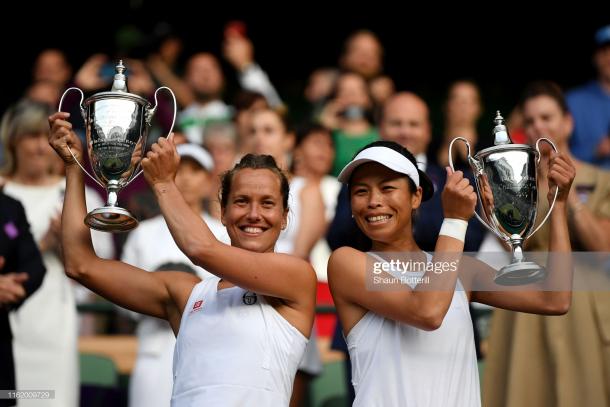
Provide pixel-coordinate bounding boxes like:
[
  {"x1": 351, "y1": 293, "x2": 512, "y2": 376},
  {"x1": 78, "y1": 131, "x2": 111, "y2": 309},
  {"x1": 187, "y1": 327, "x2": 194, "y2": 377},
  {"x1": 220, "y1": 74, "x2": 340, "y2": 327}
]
[{"x1": 346, "y1": 254, "x2": 481, "y2": 407}]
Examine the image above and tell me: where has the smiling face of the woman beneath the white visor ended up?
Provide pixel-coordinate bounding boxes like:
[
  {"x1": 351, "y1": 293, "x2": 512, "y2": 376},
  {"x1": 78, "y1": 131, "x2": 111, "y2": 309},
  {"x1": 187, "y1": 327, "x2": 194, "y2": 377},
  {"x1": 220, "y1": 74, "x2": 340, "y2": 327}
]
[{"x1": 350, "y1": 163, "x2": 421, "y2": 244}]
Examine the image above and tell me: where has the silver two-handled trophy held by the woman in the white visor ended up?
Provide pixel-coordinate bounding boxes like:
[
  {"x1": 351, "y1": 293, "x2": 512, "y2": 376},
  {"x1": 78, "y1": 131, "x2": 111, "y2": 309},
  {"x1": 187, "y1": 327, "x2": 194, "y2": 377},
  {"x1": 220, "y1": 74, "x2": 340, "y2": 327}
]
[{"x1": 449, "y1": 111, "x2": 558, "y2": 285}]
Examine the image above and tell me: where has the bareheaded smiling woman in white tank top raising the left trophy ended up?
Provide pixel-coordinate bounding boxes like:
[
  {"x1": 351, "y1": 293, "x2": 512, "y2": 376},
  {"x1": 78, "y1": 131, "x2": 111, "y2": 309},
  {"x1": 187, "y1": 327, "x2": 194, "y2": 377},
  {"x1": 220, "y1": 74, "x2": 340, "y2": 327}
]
[{"x1": 49, "y1": 112, "x2": 316, "y2": 406}]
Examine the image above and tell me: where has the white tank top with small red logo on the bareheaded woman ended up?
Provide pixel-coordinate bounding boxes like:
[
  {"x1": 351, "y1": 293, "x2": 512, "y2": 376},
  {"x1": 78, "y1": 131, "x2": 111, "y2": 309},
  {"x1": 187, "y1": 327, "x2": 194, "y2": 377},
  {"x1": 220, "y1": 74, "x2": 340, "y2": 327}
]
[{"x1": 172, "y1": 276, "x2": 307, "y2": 407}]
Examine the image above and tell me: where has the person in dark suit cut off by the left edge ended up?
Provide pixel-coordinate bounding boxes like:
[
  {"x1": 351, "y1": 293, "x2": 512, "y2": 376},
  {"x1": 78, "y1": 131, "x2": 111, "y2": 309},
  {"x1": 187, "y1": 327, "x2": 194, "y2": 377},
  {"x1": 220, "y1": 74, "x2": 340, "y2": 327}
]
[{"x1": 0, "y1": 189, "x2": 45, "y2": 407}]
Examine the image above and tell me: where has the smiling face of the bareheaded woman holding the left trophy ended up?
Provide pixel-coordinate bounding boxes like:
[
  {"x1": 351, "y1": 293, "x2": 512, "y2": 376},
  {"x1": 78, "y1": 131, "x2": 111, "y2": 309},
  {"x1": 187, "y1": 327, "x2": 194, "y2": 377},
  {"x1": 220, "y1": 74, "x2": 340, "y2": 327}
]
[{"x1": 222, "y1": 168, "x2": 288, "y2": 253}]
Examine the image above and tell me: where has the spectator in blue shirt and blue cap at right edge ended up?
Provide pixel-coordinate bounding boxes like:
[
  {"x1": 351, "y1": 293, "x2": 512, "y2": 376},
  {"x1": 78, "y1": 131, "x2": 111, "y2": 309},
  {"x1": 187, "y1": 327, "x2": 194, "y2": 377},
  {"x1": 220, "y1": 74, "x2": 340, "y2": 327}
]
[{"x1": 566, "y1": 25, "x2": 610, "y2": 169}]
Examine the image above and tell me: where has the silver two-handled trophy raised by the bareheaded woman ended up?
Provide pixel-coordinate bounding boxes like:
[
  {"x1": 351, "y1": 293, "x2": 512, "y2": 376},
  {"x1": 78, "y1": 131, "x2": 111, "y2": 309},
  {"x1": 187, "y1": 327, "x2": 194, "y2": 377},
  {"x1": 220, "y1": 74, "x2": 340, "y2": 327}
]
[{"x1": 59, "y1": 61, "x2": 176, "y2": 232}]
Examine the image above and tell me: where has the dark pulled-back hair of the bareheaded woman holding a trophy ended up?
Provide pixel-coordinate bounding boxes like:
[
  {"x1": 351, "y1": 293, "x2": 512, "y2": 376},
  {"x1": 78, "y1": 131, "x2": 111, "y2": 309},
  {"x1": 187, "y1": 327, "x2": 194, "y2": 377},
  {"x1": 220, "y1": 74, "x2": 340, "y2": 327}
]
[{"x1": 219, "y1": 154, "x2": 290, "y2": 209}]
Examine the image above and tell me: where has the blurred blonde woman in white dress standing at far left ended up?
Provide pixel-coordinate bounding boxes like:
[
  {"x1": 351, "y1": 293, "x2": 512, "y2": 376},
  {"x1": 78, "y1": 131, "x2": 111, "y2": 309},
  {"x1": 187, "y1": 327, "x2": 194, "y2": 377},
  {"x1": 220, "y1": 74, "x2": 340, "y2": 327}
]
[{"x1": 0, "y1": 100, "x2": 112, "y2": 407}]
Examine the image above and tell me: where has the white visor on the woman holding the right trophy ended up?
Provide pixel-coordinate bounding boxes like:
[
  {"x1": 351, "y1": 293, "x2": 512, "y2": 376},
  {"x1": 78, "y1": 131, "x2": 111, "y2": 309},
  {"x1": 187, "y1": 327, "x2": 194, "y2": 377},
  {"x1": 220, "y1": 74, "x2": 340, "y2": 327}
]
[{"x1": 338, "y1": 147, "x2": 419, "y2": 187}]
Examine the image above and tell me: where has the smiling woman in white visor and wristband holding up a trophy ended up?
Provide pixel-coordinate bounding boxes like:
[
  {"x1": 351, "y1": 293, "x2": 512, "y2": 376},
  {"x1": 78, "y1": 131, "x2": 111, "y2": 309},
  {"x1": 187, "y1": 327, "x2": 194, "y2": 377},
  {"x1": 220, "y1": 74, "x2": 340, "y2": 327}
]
[{"x1": 328, "y1": 141, "x2": 574, "y2": 407}]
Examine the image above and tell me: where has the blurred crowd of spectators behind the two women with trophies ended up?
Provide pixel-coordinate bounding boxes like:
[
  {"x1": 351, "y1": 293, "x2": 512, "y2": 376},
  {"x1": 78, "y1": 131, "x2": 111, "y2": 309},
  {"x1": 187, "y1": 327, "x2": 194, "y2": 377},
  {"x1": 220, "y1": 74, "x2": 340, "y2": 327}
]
[{"x1": 0, "y1": 21, "x2": 610, "y2": 407}]
